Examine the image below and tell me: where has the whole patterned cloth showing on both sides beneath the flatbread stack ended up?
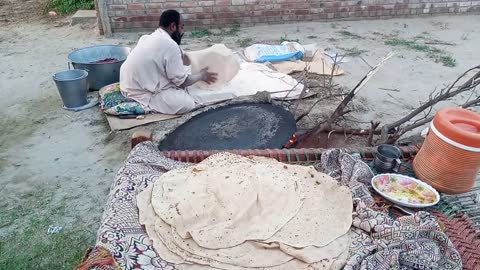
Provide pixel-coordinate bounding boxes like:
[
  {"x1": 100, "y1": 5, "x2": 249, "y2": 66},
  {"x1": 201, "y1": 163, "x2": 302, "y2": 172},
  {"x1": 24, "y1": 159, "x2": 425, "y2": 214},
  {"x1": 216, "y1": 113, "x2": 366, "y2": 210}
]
[{"x1": 87, "y1": 142, "x2": 462, "y2": 270}]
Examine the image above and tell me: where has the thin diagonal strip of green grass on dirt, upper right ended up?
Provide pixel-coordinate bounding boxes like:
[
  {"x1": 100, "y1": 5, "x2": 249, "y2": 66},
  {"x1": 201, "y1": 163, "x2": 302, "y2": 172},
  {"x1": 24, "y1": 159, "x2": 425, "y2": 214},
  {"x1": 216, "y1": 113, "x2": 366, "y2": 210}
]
[{"x1": 385, "y1": 38, "x2": 456, "y2": 67}]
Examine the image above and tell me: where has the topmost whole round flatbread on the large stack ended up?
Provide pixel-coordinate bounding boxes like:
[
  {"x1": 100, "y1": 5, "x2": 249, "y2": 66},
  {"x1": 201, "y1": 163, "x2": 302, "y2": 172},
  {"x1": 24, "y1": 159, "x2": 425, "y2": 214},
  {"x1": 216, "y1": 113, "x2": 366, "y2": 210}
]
[{"x1": 152, "y1": 153, "x2": 304, "y2": 249}]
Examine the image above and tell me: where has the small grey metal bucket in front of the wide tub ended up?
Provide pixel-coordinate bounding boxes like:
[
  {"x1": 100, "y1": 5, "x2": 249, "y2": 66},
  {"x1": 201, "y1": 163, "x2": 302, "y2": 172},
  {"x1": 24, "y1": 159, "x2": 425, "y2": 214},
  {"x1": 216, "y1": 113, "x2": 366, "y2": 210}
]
[{"x1": 53, "y1": 69, "x2": 88, "y2": 108}]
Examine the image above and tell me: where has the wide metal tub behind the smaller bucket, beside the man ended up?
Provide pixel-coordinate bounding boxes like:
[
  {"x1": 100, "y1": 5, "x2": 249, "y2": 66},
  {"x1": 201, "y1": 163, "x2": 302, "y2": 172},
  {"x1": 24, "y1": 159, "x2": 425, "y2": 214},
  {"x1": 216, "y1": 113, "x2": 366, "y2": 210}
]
[{"x1": 68, "y1": 45, "x2": 131, "y2": 90}]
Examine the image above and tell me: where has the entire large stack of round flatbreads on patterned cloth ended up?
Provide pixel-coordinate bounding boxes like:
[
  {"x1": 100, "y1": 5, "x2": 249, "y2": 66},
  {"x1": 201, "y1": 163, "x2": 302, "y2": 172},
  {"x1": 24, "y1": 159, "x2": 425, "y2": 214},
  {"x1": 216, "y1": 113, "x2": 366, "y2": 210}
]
[{"x1": 137, "y1": 153, "x2": 352, "y2": 270}]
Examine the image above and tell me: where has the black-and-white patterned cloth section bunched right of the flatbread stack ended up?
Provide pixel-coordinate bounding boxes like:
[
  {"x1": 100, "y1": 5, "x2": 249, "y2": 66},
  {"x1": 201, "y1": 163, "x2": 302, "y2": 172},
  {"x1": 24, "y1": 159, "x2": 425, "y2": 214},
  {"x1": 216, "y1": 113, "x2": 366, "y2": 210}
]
[{"x1": 318, "y1": 149, "x2": 462, "y2": 270}]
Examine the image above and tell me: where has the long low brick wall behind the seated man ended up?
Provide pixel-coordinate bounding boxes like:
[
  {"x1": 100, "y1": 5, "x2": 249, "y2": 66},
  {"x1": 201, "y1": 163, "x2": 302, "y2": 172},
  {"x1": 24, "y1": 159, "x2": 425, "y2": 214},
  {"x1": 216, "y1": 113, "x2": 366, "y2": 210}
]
[{"x1": 105, "y1": 0, "x2": 480, "y2": 32}]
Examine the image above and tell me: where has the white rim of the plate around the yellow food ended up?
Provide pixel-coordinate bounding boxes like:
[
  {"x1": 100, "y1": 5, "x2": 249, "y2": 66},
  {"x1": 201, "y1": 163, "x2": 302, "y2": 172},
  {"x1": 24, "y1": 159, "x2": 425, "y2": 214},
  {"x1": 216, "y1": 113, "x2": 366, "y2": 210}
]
[{"x1": 371, "y1": 173, "x2": 440, "y2": 208}]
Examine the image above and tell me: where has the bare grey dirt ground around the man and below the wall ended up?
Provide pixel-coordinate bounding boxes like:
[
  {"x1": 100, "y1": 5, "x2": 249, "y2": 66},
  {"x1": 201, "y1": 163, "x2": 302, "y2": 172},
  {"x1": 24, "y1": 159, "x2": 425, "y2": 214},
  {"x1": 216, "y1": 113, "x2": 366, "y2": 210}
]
[{"x1": 0, "y1": 4, "x2": 480, "y2": 269}]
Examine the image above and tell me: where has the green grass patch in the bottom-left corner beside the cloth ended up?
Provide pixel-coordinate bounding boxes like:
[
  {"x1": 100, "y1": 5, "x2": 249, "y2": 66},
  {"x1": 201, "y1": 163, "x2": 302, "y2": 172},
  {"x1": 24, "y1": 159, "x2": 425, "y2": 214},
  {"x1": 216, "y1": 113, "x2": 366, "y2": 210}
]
[{"x1": 0, "y1": 192, "x2": 95, "y2": 270}]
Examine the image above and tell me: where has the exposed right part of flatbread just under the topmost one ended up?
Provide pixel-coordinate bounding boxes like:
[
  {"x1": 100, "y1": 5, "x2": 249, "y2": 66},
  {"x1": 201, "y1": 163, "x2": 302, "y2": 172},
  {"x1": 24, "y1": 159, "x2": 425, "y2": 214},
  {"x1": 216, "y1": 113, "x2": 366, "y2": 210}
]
[{"x1": 265, "y1": 169, "x2": 353, "y2": 248}]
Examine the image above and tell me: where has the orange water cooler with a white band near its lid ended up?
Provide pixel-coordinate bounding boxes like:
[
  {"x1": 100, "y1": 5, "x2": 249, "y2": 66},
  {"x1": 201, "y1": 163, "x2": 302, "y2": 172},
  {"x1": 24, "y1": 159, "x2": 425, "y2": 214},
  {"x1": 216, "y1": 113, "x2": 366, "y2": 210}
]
[{"x1": 413, "y1": 108, "x2": 480, "y2": 194}]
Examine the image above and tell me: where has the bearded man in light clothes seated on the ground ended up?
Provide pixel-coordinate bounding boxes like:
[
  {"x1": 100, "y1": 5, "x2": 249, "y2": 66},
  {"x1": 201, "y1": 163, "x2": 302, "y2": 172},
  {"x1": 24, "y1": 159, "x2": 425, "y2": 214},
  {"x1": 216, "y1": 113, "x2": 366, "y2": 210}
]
[{"x1": 120, "y1": 10, "x2": 217, "y2": 114}]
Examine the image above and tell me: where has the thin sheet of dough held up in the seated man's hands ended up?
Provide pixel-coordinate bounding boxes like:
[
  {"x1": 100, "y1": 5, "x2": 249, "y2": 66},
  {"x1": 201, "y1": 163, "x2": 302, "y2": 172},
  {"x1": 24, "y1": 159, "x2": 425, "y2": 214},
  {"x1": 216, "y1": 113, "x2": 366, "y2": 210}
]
[{"x1": 185, "y1": 44, "x2": 240, "y2": 89}]
